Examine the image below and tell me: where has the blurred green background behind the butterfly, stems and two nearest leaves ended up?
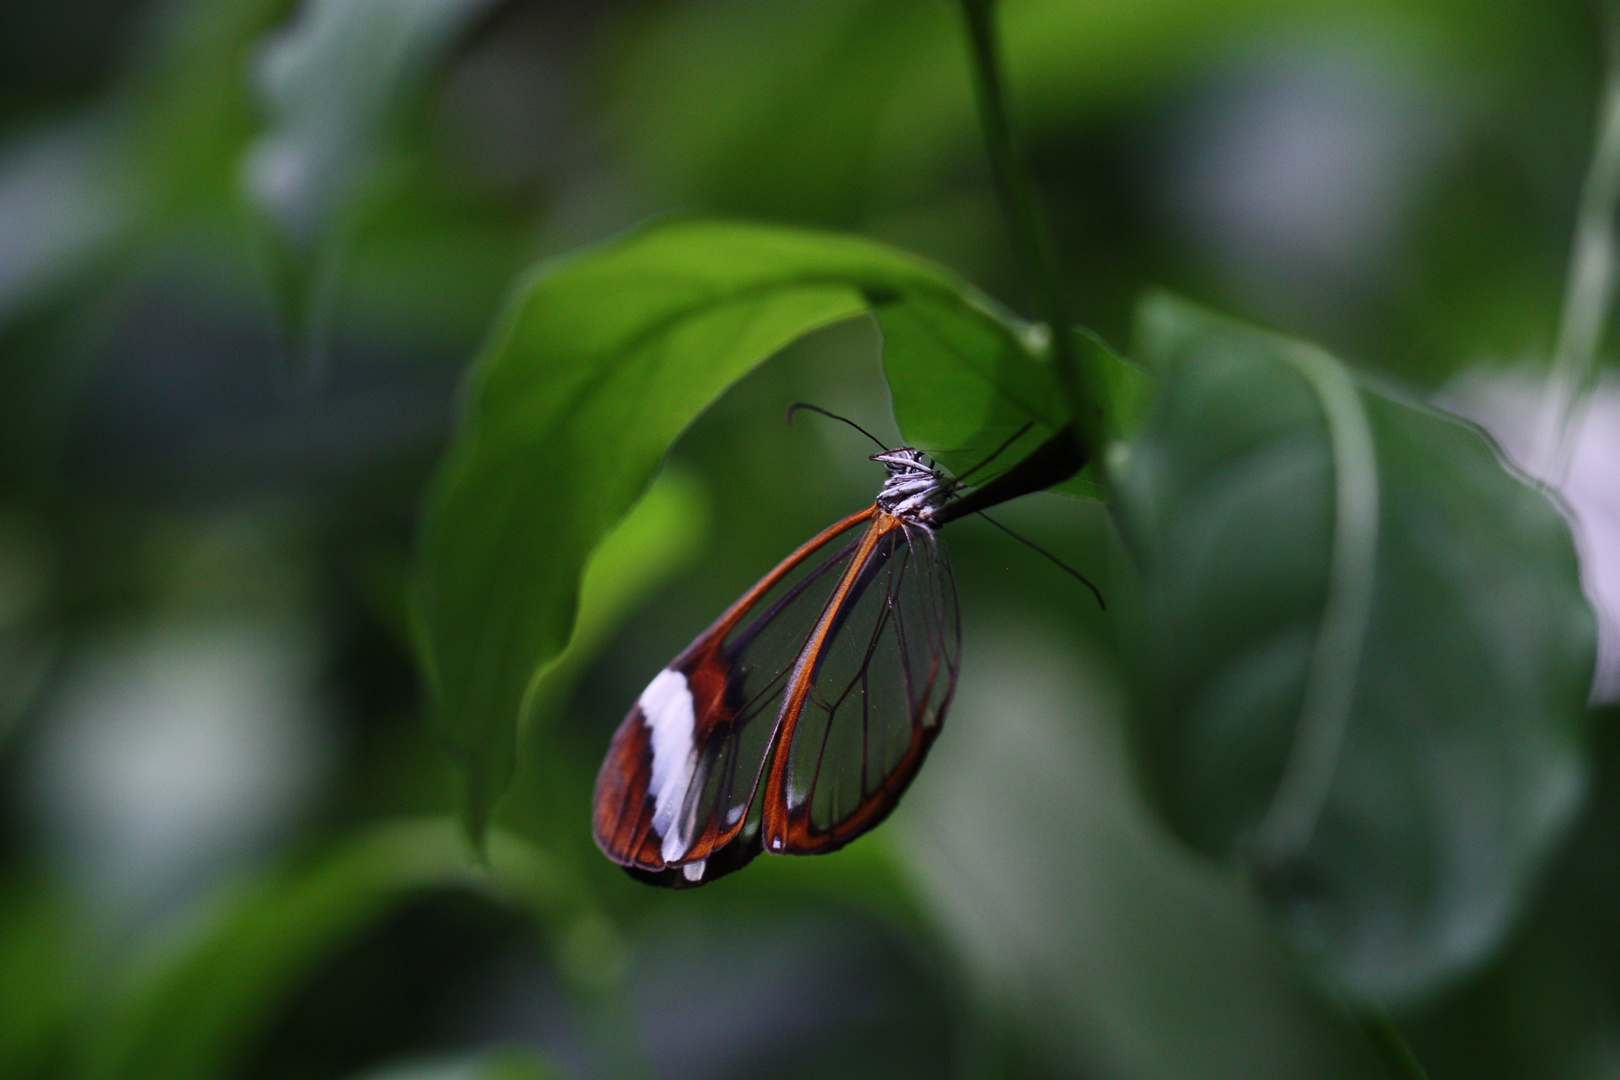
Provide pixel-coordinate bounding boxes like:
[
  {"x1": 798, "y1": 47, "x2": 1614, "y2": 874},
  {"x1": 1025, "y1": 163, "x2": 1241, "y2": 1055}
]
[{"x1": 0, "y1": 0, "x2": 1620, "y2": 1080}]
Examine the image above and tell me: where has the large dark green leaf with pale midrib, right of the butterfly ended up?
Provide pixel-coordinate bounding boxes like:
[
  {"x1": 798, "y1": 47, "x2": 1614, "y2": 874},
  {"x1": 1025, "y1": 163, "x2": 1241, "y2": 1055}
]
[{"x1": 1115, "y1": 298, "x2": 1594, "y2": 1002}]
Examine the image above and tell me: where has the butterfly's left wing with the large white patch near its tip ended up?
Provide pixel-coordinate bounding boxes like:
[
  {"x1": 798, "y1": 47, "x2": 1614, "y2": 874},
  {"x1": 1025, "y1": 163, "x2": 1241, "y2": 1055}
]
[{"x1": 595, "y1": 507, "x2": 875, "y2": 886}]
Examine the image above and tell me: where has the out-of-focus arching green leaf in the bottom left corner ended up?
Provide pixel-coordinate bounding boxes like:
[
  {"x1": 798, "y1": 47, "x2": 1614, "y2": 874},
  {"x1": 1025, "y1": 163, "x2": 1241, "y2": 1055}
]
[{"x1": 73, "y1": 819, "x2": 567, "y2": 1080}]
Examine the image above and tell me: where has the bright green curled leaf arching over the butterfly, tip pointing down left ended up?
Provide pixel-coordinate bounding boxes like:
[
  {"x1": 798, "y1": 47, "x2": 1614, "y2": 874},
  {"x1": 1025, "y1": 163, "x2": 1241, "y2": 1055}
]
[{"x1": 418, "y1": 222, "x2": 1082, "y2": 836}]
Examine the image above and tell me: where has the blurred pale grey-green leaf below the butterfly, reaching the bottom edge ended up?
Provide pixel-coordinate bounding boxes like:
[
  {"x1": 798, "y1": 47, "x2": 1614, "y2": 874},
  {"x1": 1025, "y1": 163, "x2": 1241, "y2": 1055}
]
[{"x1": 894, "y1": 621, "x2": 1390, "y2": 1080}]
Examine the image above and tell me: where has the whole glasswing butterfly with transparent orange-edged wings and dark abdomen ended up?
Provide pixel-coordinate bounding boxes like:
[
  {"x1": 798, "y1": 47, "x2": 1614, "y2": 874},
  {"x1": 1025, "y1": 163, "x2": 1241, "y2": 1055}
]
[{"x1": 593, "y1": 406, "x2": 1089, "y2": 889}]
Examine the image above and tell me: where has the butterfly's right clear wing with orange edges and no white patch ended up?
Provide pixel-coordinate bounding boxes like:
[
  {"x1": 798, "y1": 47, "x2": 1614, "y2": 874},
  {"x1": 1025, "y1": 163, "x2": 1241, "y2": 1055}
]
[{"x1": 761, "y1": 515, "x2": 961, "y2": 855}]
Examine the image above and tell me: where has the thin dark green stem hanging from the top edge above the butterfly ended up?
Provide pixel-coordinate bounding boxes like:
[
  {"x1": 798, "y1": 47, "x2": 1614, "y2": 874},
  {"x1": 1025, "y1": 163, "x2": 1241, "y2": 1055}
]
[{"x1": 962, "y1": 0, "x2": 1097, "y2": 446}]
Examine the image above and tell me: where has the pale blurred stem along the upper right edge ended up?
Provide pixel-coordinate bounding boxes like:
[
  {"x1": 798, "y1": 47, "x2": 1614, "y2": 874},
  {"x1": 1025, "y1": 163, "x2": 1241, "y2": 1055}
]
[{"x1": 1541, "y1": 0, "x2": 1620, "y2": 487}]
